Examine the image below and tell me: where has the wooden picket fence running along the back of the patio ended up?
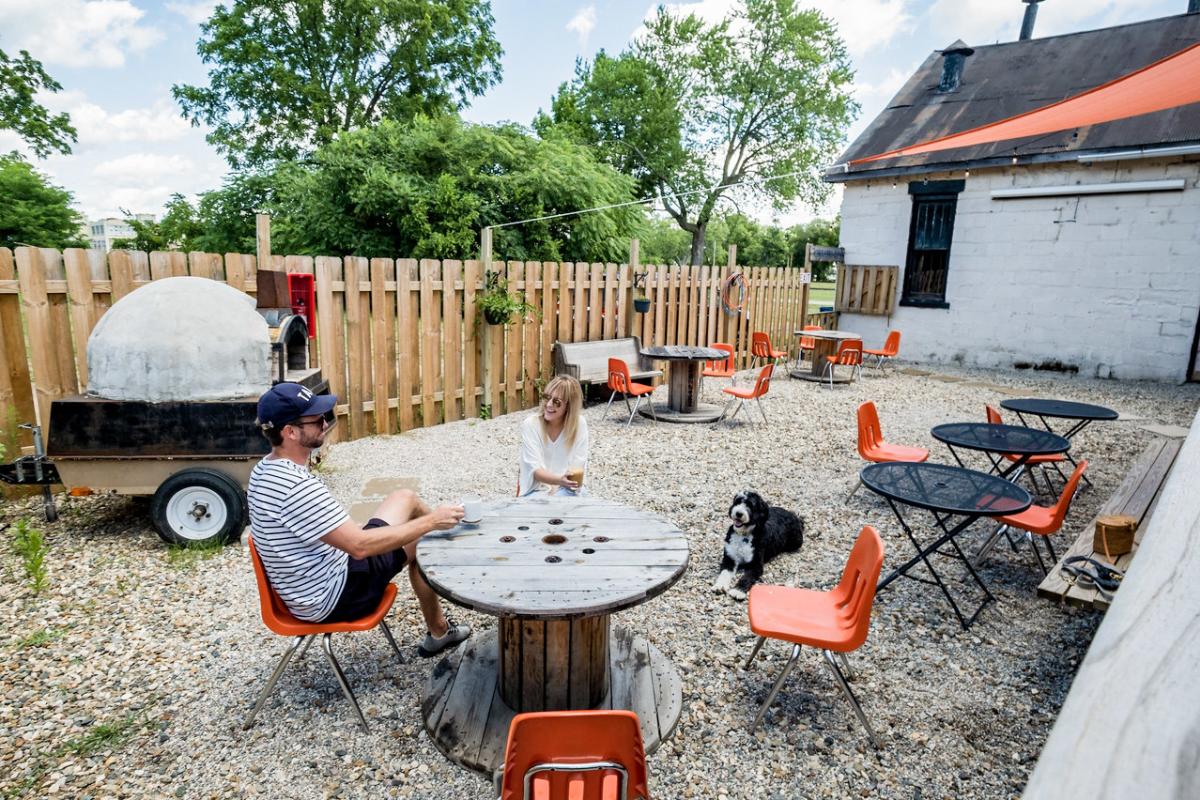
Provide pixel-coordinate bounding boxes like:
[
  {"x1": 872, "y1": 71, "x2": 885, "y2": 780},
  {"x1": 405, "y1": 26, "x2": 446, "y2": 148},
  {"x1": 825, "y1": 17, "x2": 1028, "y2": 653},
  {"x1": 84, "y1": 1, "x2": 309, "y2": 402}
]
[{"x1": 0, "y1": 247, "x2": 833, "y2": 444}]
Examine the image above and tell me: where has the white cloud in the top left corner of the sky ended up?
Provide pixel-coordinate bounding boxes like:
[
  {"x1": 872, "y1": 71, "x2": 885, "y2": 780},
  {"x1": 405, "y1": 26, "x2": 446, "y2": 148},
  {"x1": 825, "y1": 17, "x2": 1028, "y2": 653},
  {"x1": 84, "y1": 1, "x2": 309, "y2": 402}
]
[{"x1": 0, "y1": 0, "x2": 163, "y2": 67}]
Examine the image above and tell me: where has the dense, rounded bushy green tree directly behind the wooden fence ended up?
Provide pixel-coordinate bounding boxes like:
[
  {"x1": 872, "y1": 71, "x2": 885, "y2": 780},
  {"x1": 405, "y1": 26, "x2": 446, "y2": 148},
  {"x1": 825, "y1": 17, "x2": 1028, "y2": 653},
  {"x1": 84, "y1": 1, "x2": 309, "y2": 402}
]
[{"x1": 266, "y1": 115, "x2": 644, "y2": 260}]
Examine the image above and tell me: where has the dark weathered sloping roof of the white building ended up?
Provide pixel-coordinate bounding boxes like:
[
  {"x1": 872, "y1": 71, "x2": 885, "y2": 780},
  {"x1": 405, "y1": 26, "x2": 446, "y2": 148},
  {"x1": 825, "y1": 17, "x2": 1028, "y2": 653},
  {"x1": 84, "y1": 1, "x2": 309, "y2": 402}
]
[{"x1": 827, "y1": 14, "x2": 1200, "y2": 181}]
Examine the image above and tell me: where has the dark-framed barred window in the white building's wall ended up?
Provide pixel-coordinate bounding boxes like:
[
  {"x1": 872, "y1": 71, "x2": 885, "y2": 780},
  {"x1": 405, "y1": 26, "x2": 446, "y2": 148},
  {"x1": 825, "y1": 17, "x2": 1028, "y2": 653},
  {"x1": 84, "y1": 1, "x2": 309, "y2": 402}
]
[{"x1": 900, "y1": 181, "x2": 966, "y2": 308}]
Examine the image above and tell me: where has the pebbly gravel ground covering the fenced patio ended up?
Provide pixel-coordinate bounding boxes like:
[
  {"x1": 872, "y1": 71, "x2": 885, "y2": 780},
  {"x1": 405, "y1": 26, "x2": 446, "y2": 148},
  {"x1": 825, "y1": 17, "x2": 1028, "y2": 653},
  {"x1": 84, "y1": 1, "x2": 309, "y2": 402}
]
[{"x1": 7, "y1": 369, "x2": 1200, "y2": 799}]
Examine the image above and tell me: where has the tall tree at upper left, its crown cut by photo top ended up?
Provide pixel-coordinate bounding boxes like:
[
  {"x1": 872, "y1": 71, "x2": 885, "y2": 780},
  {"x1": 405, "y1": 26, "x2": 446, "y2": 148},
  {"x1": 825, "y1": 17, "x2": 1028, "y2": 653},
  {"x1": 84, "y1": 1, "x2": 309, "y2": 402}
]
[{"x1": 172, "y1": 0, "x2": 503, "y2": 168}]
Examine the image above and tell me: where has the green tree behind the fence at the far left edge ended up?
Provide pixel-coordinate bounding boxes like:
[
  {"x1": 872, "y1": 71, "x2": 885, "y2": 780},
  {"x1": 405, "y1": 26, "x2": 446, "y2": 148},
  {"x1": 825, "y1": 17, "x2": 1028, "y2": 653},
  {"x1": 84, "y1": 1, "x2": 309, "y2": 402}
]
[{"x1": 0, "y1": 152, "x2": 89, "y2": 249}]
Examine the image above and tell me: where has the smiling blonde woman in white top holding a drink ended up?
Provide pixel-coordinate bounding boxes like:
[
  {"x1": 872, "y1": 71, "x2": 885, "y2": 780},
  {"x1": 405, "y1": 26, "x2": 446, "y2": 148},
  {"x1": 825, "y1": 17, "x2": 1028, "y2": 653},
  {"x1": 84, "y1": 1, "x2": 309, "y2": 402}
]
[{"x1": 517, "y1": 375, "x2": 588, "y2": 497}]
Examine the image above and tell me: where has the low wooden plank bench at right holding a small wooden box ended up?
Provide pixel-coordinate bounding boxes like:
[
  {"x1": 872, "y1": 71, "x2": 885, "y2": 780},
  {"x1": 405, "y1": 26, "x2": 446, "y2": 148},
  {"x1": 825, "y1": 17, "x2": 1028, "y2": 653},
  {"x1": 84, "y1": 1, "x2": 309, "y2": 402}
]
[{"x1": 1038, "y1": 438, "x2": 1183, "y2": 610}]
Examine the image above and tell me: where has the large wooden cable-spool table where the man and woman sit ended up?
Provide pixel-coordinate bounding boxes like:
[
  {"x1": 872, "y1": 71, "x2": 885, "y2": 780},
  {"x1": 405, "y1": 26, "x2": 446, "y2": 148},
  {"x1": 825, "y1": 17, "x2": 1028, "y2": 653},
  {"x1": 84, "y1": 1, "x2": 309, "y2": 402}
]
[{"x1": 416, "y1": 495, "x2": 688, "y2": 775}]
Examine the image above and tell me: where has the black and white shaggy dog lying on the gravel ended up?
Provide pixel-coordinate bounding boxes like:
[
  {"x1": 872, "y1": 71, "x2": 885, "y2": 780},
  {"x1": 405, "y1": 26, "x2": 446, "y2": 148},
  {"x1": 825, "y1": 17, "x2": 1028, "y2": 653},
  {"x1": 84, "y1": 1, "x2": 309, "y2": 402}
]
[{"x1": 713, "y1": 492, "x2": 804, "y2": 600}]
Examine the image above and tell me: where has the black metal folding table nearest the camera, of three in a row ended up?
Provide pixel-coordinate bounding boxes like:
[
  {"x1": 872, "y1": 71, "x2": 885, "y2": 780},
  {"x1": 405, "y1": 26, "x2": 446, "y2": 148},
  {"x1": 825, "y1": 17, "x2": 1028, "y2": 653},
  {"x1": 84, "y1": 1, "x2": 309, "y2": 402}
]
[{"x1": 862, "y1": 462, "x2": 1033, "y2": 630}]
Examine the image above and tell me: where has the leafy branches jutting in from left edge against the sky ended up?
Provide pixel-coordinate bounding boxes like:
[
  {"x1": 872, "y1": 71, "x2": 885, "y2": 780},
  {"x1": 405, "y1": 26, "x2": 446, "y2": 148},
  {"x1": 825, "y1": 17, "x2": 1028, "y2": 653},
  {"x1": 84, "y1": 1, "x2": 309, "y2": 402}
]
[{"x1": 0, "y1": 50, "x2": 76, "y2": 158}]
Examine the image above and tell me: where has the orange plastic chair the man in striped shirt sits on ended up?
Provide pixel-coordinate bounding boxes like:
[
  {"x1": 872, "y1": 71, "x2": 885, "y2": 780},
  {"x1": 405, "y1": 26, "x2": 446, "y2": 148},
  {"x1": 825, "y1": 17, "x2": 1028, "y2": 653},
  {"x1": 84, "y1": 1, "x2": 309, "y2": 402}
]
[{"x1": 242, "y1": 539, "x2": 404, "y2": 730}]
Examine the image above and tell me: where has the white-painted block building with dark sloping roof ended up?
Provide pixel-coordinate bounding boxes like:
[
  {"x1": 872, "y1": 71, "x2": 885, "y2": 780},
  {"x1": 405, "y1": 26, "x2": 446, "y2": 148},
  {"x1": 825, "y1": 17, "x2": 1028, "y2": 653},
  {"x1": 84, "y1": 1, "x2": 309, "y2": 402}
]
[{"x1": 827, "y1": 5, "x2": 1200, "y2": 381}]
